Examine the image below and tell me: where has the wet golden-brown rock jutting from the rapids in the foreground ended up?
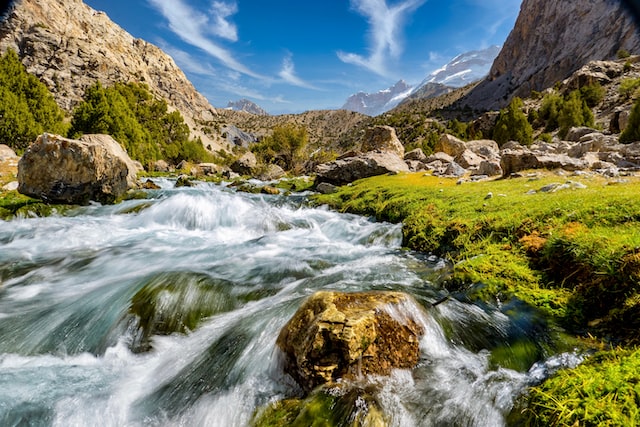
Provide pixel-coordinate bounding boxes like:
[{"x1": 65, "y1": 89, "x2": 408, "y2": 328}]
[{"x1": 277, "y1": 291, "x2": 424, "y2": 391}]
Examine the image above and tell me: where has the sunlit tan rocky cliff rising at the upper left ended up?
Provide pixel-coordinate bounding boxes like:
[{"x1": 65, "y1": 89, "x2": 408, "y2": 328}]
[{"x1": 0, "y1": 0, "x2": 220, "y2": 149}]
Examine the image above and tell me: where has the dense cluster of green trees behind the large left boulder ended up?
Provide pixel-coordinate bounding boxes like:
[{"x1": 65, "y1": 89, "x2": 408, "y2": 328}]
[{"x1": 69, "y1": 82, "x2": 210, "y2": 166}]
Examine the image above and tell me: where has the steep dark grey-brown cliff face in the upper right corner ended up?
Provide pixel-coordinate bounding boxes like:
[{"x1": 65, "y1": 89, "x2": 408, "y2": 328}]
[{"x1": 462, "y1": 0, "x2": 640, "y2": 109}]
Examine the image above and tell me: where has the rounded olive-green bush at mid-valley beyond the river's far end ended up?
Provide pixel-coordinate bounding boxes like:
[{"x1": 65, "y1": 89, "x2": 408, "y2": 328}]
[{"x1": 251, "y1": 124, "x2": 309, "y2": 172}]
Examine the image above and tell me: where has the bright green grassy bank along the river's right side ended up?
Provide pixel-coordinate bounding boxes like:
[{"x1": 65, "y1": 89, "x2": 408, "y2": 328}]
[{"x1": 316, "y1": 172, "x2": 640, "y2": 425}]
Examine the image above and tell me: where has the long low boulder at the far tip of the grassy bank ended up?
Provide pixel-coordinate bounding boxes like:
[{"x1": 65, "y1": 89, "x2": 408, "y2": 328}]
[{"x1": 316, "y1": 151, "x2": 409, "y2": 185}]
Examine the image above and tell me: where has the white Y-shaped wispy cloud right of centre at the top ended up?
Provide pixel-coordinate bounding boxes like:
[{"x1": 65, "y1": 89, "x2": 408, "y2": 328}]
[{"x1": 338, "y1": 0, "x2": 426, "y2": 76}]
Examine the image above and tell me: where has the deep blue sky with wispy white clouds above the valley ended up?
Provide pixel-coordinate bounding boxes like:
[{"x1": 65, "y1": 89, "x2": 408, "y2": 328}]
[{"x1": 85, "y1": 0, "x2": 522, "y2": 114}]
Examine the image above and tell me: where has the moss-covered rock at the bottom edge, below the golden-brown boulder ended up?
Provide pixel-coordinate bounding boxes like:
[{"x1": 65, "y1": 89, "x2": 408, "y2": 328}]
[{"x1": 251, "y1": 389, "x2": 388, "y2": 427}]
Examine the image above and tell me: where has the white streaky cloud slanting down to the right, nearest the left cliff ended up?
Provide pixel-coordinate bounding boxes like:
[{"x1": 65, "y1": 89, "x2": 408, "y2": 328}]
[{"x1": 148, "y1": 0, "x2": 263, "y2": 78}]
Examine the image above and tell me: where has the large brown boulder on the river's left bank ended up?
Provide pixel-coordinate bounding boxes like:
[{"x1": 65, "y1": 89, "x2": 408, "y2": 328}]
[{"x1": 18, "y1": 133, "x2": 138, "y2": 204}]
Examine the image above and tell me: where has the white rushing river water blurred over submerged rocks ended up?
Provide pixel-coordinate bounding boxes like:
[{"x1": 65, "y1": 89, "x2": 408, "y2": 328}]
[{"x1": 0, "y1": 180, "x2": 580, "y2": 427}]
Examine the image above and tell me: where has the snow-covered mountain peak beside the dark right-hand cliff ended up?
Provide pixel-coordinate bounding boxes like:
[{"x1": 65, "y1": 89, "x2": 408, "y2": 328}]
[{"x1": 418, "y1": 46, "x2": 500, "y2": 87}]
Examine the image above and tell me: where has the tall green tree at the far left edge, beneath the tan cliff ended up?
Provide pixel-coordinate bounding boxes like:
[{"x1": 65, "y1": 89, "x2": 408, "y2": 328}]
[{"x1": 0, "y1": 49, "x2": 68, "y2": 153}]
